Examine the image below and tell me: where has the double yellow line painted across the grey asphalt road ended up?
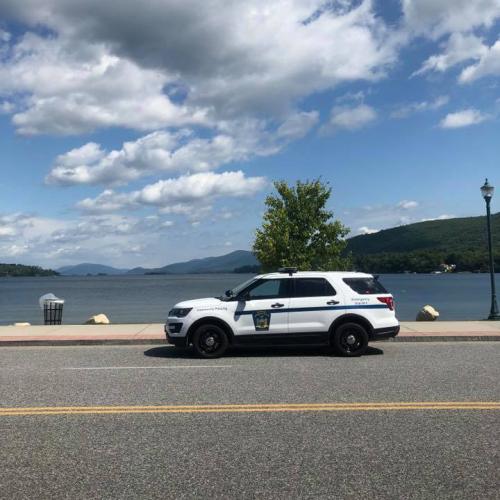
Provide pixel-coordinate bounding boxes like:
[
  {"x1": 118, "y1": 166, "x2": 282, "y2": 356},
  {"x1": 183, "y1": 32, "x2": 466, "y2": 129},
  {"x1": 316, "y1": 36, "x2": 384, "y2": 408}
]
[{"x1": 0, "y1": 401, "x2": 500, "y2": 417}]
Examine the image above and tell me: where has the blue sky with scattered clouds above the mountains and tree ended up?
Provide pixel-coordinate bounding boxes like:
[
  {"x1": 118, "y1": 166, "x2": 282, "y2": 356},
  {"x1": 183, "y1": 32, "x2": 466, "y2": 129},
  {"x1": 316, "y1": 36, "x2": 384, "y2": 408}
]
[{"x1": 0, "y1": 0, "x2": 500, "y2": 267}]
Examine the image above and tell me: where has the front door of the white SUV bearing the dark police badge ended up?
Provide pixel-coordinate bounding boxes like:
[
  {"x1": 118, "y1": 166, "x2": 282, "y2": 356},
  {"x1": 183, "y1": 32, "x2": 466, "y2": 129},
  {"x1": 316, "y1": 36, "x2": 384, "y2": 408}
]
[{"x1": 234, "y1": 277, "x2": 291, "y2": 340}]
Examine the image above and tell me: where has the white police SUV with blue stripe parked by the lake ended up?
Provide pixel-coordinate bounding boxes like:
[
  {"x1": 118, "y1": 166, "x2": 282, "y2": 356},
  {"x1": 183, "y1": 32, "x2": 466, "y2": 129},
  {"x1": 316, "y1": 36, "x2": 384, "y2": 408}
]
[{"x1": 165, "y1": 268, "x2": 399, "y2": 358}]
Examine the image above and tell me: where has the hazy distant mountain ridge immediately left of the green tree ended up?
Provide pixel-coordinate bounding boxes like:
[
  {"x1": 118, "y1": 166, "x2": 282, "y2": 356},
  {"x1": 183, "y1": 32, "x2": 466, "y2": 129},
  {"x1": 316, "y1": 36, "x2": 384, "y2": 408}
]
[{"x1": 140, "y1": 250, "x2": 259, "y2": 274}]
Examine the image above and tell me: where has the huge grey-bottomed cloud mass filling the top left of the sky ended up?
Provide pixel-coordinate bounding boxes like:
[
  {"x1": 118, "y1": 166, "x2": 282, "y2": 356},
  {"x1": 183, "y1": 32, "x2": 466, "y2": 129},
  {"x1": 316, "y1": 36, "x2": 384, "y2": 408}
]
[{"x1": 0, "y1": 0, "x2": 397, "y2": 134}]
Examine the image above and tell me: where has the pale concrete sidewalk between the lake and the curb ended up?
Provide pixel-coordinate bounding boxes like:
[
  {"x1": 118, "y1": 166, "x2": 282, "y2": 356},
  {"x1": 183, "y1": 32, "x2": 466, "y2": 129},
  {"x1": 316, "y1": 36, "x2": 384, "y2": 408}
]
[{"x1": 0, "y1": 321, "x2": 500, "y2": 346}]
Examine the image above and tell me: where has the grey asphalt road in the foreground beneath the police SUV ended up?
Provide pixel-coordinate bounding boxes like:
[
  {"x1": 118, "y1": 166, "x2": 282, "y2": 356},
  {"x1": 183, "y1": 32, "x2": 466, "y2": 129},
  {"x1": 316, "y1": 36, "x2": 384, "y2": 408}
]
[{"x1": 0, "y1": 342, "x2": 500, "y2": 499}]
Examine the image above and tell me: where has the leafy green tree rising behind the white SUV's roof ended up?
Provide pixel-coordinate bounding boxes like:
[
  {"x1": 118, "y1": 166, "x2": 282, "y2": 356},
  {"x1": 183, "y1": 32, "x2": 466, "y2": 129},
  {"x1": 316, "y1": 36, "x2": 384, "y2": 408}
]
[{"x1": 253, "y1": 179, "x2": 351, "y2": 271}]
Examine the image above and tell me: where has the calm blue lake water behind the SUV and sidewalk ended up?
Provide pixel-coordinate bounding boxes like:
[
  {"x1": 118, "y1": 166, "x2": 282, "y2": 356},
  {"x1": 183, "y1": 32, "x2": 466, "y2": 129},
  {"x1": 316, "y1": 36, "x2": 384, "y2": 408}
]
[{"x1": 0, "y1": 274, "x2": 498, "y2": 325}]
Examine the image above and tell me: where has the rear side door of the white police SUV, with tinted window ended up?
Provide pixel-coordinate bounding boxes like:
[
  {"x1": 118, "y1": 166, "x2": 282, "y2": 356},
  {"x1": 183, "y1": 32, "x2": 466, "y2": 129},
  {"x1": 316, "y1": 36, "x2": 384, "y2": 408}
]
[{"x1": 288, "y1": 277, "x2": 344, "y2": 342}]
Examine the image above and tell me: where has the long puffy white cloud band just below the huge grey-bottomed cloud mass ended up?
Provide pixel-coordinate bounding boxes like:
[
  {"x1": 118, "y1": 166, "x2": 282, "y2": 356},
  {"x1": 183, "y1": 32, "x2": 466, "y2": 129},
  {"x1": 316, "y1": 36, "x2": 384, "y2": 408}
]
[{"x1": 46, "y1": 111, "x2": 318, "y2": 185}]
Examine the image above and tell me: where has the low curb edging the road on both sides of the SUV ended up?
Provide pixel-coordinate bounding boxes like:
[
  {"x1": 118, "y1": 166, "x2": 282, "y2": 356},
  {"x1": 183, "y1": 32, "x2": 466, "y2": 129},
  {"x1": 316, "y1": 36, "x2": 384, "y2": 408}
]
[{"x1": 0, "y1": 335, "x2": 500, "y2": 347}]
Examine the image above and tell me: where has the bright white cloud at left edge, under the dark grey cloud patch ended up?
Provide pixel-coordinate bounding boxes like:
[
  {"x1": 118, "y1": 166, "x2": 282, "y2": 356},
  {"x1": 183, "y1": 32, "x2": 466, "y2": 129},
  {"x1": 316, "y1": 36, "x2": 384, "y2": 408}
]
[{"x1": 0, "y1": 33, "x2": 206, "y2": 135}]
